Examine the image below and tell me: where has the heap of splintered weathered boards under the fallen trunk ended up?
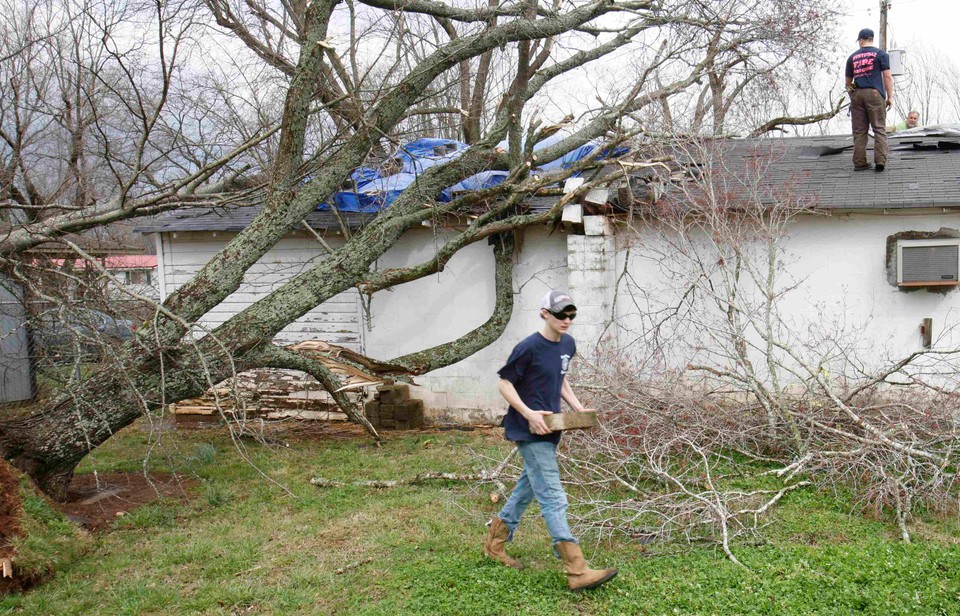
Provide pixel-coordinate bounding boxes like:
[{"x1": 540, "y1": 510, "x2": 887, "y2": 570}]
[{"x1": 170, "y1": 369, "x2": 356, "y2": 423}]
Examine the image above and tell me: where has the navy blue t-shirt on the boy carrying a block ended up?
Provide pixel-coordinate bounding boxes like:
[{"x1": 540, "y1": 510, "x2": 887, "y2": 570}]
[{"x1": 497, "y1": 332, "x2": 577, "y2": 443}]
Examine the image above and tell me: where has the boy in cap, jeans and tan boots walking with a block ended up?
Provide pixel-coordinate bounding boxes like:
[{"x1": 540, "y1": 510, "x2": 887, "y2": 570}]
[{"x1": 483, "y1": 291, "x2": 617, "y2": 592}]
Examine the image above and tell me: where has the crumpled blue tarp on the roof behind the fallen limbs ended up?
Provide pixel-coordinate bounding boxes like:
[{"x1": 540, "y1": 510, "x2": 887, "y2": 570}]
[{"x1": 317, "y1": 135, "x2": 629, "y2": 212}]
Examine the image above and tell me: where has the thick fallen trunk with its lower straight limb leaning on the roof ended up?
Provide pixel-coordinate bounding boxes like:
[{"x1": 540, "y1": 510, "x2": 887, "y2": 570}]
[{"x1": 0, "y1": 142, "x2": 509, "y2": 500}]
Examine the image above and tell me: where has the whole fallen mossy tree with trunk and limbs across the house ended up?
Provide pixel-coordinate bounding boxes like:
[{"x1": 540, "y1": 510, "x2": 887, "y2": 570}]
[{"x1": 0, "y1": 0, "x2": 840, "y2": 498}]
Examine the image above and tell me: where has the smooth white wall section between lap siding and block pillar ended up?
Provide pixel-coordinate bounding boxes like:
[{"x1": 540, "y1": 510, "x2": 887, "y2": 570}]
[{"x1": 365, "y1": 228, "x2": 567, "y2": 421}]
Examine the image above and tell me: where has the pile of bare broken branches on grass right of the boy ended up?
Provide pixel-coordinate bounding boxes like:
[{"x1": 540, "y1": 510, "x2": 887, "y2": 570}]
[{"x1": 562, "y1": 348, "x2": 960, "y2": 562}]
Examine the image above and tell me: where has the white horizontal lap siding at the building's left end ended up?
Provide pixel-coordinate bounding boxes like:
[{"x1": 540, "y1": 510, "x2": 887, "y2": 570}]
[{"x1": 160, "y1": 232, "x2": 363, "y2": 351}]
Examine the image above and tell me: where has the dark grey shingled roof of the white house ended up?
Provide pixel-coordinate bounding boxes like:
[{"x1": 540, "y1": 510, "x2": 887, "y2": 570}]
[{"x1": 136, "y1": 132, "x2": 960, "y2": 233}]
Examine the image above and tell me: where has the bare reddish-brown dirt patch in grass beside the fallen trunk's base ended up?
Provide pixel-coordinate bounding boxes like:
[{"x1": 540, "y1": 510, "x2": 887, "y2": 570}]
[{"x1": 56, "y1": 472, "x2": 196, "y2": 531}]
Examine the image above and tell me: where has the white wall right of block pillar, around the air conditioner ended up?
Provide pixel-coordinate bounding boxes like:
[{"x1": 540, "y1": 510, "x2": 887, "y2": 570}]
[{"x1": 608, "y1": 212, "x2": 960, "y2": 382}]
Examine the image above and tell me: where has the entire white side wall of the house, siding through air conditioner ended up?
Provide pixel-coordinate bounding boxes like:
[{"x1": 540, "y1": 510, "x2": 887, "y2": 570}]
[{"x1": 152, "y1": 212, "x2": 960, "y2": 421}]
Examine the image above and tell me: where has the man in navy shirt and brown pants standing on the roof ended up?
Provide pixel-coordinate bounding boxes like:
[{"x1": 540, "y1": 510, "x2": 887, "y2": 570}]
[{"x1": 846, "y1": 28, "x2": 893, "y2": 171}]
